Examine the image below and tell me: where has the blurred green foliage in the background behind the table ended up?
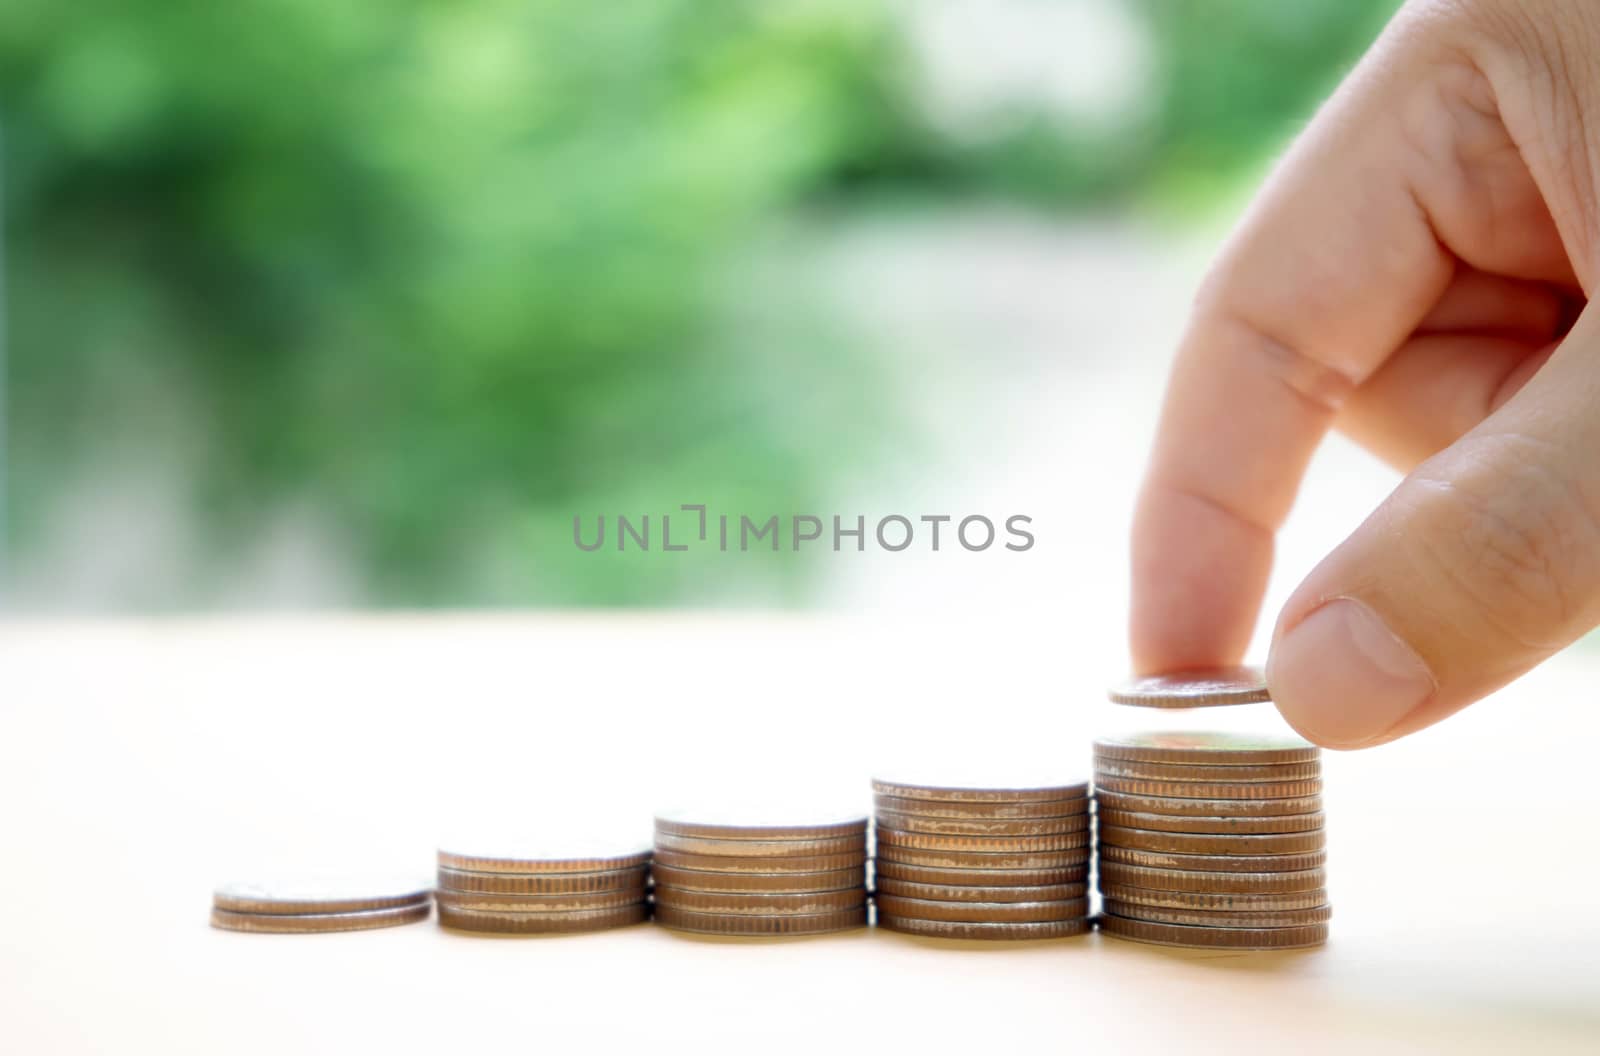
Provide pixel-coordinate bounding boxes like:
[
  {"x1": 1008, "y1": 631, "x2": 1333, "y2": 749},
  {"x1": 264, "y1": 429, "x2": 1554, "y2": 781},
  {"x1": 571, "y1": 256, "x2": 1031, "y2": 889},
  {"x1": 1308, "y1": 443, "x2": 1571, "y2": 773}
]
[{"x1": 0, "y1": 0, "x2": 1395, "y2": 608}]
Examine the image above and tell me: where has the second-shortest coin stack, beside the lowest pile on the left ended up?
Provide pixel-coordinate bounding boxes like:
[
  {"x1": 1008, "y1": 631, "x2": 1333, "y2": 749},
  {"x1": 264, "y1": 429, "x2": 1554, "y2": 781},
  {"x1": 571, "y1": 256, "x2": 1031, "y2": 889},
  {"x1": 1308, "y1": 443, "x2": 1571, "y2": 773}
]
[{"x1": 434, "y1": 846, "x2": 650, "y2": 934}]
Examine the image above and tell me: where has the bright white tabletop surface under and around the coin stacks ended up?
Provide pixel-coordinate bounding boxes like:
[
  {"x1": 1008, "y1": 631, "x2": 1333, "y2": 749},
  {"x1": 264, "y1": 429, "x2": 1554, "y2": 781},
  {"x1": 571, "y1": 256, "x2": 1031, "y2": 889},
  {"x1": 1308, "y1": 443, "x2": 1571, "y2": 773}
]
[{"x1": 0, "y1": 614, "x2": 1600, "y2": 1053}]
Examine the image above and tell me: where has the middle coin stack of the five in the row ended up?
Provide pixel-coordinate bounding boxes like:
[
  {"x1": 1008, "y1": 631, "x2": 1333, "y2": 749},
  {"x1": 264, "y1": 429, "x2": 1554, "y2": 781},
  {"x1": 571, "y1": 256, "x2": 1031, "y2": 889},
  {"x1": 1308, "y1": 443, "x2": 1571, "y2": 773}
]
[{"x1": 654, "y1": 813, "x2": 867, "y2": 936}]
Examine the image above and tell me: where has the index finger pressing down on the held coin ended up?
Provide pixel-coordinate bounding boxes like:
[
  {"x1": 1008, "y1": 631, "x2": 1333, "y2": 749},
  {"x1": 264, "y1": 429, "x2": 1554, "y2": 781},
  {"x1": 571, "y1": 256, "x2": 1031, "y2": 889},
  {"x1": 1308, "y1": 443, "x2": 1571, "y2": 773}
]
[{"x1": 1130, "y1": 24, "x2": 1454, "y2": 672}]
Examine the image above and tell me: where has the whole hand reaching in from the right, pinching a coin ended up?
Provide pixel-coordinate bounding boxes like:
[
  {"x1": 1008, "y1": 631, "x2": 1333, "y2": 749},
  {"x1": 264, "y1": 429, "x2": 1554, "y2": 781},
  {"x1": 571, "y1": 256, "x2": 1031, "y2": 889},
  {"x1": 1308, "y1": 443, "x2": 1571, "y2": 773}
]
[{"x1": 1131, "y1": 0, "x2": 1600, "y2": 747}]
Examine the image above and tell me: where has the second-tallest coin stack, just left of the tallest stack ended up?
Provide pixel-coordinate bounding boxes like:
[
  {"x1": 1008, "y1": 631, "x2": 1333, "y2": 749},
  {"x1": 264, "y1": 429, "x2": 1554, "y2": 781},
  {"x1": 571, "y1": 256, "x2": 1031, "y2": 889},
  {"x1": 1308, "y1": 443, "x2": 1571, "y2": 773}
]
[{"x1": 872, "y1": 779, "x2": 1090, "y2": 939}]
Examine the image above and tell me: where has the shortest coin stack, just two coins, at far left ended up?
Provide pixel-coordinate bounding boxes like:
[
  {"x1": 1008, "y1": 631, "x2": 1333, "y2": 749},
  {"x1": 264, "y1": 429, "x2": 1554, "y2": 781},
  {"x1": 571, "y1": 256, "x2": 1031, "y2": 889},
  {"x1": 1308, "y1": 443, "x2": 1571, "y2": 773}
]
[{"x1": 211, "y1": 878, "x2": 432, "y2": 933}]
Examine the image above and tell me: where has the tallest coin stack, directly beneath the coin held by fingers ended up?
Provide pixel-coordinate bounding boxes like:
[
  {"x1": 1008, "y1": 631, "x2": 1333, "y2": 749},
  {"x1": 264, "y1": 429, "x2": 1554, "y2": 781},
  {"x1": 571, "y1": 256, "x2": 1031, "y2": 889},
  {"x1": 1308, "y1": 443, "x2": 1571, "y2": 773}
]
[{"x1": 1094, "y1": 733, "x2": 1331, "y2": 949}]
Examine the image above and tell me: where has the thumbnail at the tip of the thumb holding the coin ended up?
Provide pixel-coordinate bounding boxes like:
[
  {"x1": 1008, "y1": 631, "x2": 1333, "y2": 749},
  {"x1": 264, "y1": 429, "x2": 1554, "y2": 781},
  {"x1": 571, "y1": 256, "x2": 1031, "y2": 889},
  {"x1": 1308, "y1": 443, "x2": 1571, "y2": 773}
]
[{"x1": 1267, "y1": 598, "x2": 1435, "y2": 747}]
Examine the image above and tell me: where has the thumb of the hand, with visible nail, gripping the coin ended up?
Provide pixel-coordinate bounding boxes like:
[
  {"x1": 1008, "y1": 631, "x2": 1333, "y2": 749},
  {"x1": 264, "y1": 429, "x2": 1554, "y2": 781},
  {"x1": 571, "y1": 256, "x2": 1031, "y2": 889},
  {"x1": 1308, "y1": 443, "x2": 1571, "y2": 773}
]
[{"x1": 1267, "y1": 309, "x2": 1600, "y2": 749}]
